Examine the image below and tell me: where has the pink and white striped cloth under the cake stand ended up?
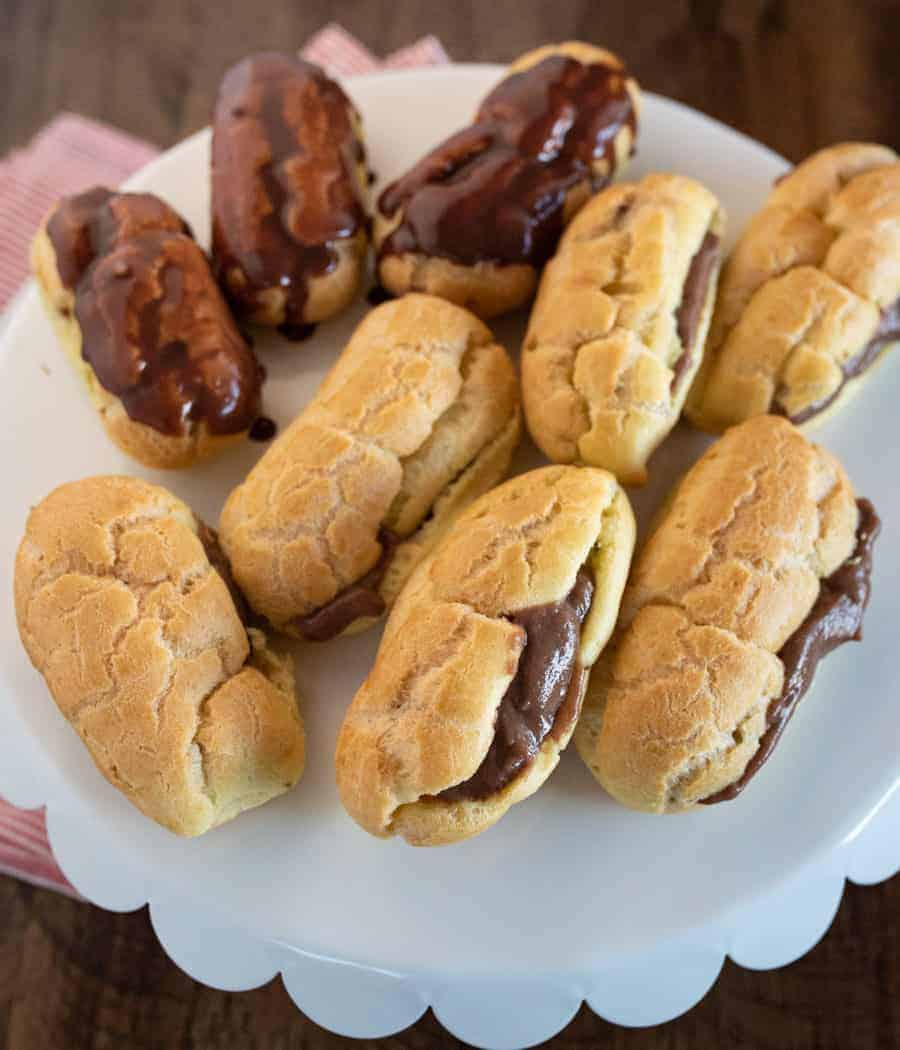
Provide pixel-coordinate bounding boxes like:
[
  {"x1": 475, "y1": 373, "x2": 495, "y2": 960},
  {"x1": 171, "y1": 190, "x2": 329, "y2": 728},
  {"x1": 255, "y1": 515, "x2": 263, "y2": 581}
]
[{"x1": 0, "y1": 24, "x2": 449, "y2": 896}]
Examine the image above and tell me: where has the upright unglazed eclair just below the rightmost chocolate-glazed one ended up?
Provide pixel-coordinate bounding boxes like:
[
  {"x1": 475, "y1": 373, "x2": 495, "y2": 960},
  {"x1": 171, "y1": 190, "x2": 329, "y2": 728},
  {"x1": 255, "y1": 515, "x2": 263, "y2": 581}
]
[{"x1": 522, "y1": 174, "x2": 725, "y2": 485}]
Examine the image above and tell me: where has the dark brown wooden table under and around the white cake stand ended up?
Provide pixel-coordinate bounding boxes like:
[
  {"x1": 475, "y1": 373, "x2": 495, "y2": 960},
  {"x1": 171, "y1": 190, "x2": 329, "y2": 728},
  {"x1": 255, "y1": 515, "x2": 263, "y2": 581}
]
[{"x1": 0, "y1": 0, "x2": 900, "y2": 1050}]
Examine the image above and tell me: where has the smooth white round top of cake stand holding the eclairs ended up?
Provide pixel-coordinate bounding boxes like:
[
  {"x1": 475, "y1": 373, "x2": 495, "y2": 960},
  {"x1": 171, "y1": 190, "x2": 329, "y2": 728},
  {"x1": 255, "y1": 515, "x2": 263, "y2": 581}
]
[{"x1": 0, "y1": 65, "x2": 900, "y2": 1045}]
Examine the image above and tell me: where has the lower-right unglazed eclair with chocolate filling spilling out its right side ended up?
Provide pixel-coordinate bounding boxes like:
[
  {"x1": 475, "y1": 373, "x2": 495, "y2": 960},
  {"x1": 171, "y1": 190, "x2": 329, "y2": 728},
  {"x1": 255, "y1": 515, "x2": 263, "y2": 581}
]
[{"x1": 575, "y1": 416, "x2": 879, "y2": 813}]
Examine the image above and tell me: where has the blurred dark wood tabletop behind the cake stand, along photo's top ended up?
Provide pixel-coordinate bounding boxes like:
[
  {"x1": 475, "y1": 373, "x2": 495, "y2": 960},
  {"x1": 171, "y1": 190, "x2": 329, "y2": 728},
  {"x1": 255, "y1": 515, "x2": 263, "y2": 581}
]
[{"x1": 0, "y1": 0, "x2": 900, "y2": 160}]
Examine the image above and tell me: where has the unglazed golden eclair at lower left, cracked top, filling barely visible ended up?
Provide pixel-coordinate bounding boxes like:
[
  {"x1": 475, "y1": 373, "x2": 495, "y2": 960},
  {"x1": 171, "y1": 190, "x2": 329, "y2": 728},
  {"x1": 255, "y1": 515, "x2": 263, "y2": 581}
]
[{"x1": 15, "y1": 477, "x2": 304, "y2": 836}]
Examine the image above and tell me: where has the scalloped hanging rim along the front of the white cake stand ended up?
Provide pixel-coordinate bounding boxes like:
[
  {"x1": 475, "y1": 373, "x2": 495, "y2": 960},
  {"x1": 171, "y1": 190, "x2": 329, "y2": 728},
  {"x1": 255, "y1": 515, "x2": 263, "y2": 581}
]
[{"x1": 35, "y1": 784, "x2": 900, "y2": 1050}]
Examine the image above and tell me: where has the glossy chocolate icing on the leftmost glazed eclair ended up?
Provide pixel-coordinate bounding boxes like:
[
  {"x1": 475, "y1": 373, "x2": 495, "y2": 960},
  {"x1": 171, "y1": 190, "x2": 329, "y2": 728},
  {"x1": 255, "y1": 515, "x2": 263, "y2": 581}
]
[{"x1": 47, "y1": 188, "x2": 261, "y2": 436}]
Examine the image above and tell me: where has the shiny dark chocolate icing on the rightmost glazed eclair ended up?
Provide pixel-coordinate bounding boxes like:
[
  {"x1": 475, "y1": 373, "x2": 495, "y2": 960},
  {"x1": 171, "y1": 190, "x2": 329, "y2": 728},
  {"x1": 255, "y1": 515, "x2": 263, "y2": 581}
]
[{"x1": 378, "y1": 55, "x2": 636, "y2": 266}]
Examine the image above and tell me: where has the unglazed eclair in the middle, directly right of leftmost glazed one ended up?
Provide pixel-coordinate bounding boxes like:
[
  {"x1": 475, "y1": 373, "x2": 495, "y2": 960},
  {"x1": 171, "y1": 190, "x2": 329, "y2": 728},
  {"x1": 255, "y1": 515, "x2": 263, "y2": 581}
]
[{"x1": 221, "y1": 295, "x2": 520, "y2": 641}]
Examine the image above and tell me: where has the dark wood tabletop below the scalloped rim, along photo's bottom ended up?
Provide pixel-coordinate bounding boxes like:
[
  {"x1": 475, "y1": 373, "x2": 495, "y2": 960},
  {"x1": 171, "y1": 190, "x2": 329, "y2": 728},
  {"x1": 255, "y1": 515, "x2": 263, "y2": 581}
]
[{"x1": 0, "y1": 878, "x2": 900, "y2": 1050}]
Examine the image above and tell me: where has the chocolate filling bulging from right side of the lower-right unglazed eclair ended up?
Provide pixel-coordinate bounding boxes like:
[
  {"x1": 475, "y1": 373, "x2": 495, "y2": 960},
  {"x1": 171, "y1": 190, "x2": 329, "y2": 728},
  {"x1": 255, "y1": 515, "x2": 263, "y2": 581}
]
[{"x1": 700, "y1": 500, "x2": 881, "y2": 805}]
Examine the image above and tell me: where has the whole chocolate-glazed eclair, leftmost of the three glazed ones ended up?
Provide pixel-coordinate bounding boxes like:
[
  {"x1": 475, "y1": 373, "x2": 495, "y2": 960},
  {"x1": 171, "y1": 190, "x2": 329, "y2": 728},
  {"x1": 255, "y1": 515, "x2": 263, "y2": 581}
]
[{"x1": 32, "y1": 187, "x2": 263, "y2": 468}]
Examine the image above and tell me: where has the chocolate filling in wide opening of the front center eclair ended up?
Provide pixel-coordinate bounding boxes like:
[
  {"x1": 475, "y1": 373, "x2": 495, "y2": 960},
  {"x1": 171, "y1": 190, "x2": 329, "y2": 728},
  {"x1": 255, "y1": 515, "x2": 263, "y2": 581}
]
[{"x1": 436, "y1": 562, "x2": 594, "y2": 802}]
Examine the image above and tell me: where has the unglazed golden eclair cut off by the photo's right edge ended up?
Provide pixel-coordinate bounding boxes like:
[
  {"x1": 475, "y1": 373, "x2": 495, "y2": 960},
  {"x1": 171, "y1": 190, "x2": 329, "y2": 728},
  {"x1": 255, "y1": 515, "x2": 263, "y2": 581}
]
[{"x1": 686, "y1": 143, "x2": 900, "y2": 431}]
